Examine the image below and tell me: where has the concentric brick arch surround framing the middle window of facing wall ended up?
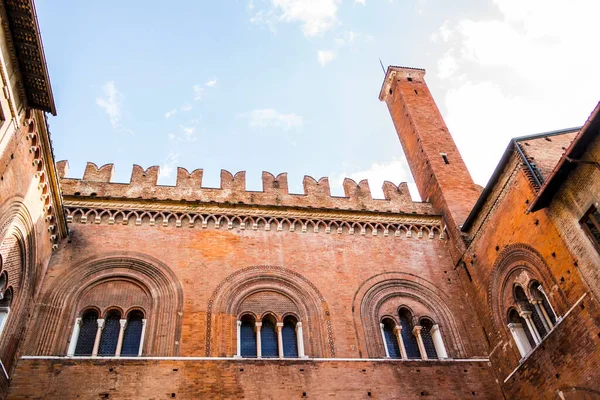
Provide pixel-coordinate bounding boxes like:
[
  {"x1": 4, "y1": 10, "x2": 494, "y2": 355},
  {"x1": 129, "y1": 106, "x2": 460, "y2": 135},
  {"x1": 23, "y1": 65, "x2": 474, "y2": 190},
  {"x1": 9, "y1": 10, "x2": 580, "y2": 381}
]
[{"x1": 206, "y1": 265, "x2": 335, "y2": 357}]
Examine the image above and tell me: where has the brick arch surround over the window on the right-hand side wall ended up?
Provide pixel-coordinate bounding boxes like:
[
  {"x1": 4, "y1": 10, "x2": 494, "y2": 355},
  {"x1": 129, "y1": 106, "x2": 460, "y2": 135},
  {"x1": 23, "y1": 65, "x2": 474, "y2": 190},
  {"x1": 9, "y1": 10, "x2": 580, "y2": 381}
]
[{"x1": 488, "y1": 243, "x2": 567, "y2": 332}]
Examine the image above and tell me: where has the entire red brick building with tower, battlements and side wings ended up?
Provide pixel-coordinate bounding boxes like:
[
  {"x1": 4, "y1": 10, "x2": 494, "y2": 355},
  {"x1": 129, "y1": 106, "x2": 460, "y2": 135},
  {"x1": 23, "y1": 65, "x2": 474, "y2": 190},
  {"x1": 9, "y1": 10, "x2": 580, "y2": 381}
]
[{"x1": 0, "y1": 0, "x2": 600, "y2": 399}]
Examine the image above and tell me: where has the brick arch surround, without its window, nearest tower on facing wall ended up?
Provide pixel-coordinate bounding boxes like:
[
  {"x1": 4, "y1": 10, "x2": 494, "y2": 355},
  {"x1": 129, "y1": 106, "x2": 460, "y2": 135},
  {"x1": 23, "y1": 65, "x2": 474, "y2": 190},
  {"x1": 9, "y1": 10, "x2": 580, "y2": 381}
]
[{"x1": 352, "y1": 272, "x2": 466, "y2": 358}]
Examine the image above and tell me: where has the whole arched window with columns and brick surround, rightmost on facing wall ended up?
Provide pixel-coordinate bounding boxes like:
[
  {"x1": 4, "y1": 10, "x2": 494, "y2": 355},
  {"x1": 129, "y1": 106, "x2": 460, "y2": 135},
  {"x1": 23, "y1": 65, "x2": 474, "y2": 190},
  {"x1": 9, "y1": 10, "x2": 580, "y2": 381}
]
[{"x1": 353, "y1": 273, "x2": 468, "y2": 360}]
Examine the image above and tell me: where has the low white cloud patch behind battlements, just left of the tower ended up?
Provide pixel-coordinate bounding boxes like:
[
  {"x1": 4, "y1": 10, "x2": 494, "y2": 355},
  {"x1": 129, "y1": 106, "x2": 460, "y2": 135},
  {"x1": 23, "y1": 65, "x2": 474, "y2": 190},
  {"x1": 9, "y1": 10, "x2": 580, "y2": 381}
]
[{"x1": 330, "y1": 159, "x2": 420, "y2": 201}]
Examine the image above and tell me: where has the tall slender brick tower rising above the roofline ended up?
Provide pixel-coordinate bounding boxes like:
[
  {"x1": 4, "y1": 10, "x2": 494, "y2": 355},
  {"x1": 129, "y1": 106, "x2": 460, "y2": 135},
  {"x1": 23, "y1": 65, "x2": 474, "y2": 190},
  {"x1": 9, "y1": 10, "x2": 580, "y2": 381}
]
[{"x1": 379, "y1": 66, "x2": 480, "y2": 253}]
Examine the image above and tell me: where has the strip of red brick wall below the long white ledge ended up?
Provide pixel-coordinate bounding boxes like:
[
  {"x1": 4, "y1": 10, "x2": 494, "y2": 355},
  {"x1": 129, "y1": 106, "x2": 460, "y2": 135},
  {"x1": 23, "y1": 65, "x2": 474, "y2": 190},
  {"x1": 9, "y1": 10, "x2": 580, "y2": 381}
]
[{"x1": 10, "y1": 360, "x2": 502, "y2": 399}]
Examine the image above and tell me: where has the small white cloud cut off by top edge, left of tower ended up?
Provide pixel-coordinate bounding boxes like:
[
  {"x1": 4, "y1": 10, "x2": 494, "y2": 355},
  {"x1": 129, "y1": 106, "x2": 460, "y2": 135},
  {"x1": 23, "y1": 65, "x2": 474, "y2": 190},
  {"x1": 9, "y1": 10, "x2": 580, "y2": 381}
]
[{"x1": 248, "y1": 0, "x2": 342, "y2": 37}]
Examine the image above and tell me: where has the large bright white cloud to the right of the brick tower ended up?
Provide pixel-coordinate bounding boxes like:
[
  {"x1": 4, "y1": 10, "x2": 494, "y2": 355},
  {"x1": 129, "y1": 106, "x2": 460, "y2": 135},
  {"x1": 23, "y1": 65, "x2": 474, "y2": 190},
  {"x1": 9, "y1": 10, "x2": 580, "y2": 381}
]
[{"x1": 437, "y1": 0, "x2": 600, "y2": 184}]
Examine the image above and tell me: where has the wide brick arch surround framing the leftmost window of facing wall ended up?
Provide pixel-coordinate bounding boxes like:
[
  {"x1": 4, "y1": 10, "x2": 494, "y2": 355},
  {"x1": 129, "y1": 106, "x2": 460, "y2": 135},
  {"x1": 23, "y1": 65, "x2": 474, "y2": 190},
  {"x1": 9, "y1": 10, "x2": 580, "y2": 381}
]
[{"x1": 30, "y1": 252, "x2": 183, "y2": 356}]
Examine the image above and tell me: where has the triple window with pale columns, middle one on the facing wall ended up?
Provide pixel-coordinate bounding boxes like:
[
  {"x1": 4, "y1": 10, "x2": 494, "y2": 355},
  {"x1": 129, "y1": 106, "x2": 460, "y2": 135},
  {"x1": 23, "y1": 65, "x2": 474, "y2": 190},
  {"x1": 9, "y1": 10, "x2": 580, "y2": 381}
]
[{"x1": 236, "y1": 312, "x2": 305, "y2": 358}]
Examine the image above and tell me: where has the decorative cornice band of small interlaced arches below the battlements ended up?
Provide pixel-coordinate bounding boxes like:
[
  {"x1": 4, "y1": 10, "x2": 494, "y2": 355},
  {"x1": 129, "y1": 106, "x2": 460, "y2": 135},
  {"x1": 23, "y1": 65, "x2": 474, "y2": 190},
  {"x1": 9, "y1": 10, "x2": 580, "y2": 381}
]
[{"x1": 64, "y1": 196, "x2": 445, "y2": 239}]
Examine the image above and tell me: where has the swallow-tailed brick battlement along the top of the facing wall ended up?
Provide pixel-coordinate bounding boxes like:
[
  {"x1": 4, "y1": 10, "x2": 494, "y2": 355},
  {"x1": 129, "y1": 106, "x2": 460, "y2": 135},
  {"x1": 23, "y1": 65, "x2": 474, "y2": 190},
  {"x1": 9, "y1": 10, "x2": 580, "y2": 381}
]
[{"x1": 57, "y1": 161, "x2": 435, "y2": 215}]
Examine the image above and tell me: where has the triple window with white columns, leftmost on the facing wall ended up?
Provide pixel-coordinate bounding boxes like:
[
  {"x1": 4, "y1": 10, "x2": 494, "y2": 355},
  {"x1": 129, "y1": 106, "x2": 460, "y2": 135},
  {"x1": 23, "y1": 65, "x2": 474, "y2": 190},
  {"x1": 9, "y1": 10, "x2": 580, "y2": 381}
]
[{"x1": 67, "y1": 307, "x2": 146, "y2": 357}]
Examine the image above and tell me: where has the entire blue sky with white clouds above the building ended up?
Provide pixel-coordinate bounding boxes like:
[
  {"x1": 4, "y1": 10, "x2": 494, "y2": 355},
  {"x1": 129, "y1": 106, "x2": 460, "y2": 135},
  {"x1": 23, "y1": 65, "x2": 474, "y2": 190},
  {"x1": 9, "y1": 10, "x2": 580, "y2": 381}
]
[{"x1": 36, "y1": 0, "x2": 600, "y2": 197}]
